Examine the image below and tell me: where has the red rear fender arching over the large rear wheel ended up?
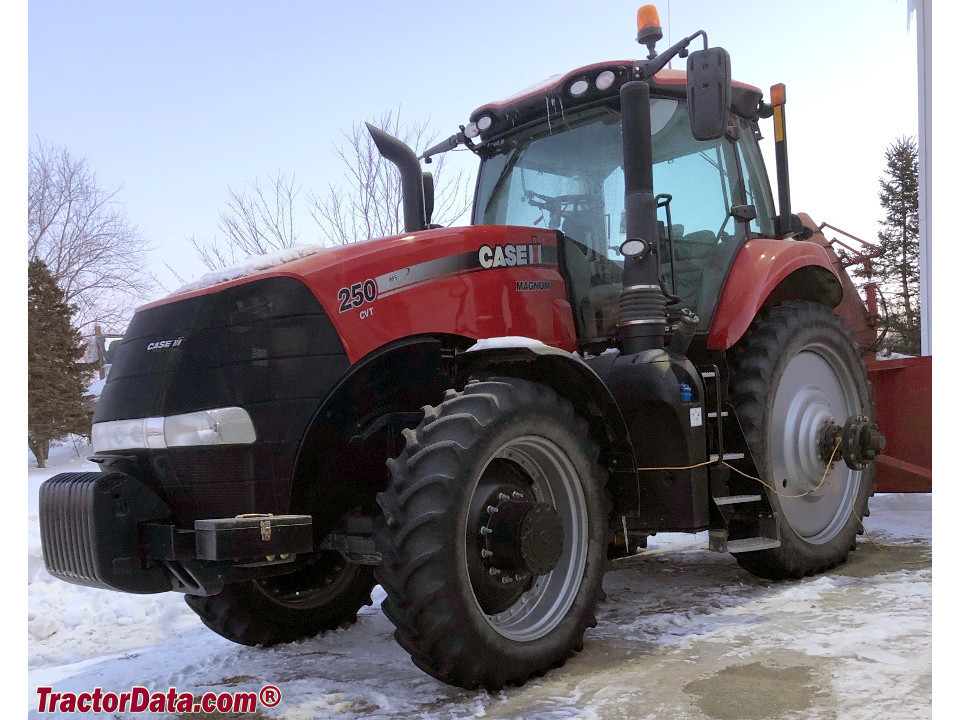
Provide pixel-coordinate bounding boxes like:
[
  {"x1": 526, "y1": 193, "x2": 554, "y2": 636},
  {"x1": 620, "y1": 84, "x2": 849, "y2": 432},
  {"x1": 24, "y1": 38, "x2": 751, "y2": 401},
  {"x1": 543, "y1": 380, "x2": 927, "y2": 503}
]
[{"x1": 707, "y1": 238, "x2": 843, "y2": 350}]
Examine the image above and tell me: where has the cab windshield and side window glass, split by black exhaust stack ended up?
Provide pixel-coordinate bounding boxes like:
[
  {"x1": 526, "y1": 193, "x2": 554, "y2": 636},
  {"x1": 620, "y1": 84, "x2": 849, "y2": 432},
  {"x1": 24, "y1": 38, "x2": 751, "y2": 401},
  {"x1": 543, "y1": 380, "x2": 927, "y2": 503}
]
[{"x1": 473, "y1": 98, "x2": 745, "y2": 336}]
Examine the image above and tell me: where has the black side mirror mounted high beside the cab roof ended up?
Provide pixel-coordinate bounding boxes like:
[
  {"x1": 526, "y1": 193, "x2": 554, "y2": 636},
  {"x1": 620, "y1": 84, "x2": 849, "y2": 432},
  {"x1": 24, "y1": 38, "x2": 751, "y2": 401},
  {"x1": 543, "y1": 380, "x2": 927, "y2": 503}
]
[{"x1": 687, "y1": 47, "x2": 730, "y2": 140}]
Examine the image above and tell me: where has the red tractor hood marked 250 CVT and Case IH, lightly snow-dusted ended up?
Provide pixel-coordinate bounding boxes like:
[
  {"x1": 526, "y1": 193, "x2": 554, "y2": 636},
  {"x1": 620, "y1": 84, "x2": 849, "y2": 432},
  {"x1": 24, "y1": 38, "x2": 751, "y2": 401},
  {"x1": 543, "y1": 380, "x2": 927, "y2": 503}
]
[{"x1": 139, "y1": 225, "x2": 572, "y2": 362}]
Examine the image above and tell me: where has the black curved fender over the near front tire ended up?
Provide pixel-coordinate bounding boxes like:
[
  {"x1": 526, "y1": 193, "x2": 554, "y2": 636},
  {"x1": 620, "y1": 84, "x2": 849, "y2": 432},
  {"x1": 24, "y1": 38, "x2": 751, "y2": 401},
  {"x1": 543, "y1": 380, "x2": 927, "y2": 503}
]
[{"x1": 456, "y1": 343, "x2": 638, "y2": 515}]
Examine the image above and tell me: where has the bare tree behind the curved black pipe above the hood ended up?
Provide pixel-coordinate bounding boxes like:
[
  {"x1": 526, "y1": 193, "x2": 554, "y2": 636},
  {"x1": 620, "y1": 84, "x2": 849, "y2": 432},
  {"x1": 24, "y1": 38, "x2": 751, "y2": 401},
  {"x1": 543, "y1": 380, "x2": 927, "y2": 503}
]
[{"x1": 309, "y1": 110, "x2": 469, "y2": 245}]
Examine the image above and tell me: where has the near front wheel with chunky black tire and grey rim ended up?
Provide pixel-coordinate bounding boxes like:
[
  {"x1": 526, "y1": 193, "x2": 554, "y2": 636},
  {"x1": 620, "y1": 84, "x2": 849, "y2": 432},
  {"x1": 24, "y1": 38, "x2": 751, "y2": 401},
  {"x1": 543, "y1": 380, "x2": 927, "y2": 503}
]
[{"x1": 375, "y1": 378, "x2": 606, "y2": 690}]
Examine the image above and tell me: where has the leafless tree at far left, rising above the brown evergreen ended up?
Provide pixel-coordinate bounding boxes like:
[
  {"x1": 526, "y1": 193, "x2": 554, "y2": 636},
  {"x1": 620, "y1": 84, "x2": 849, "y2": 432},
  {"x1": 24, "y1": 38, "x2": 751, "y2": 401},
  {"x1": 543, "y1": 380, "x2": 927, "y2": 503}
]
[{"x1": 27, "y1": 143, "x2": 155, "y2": 329}]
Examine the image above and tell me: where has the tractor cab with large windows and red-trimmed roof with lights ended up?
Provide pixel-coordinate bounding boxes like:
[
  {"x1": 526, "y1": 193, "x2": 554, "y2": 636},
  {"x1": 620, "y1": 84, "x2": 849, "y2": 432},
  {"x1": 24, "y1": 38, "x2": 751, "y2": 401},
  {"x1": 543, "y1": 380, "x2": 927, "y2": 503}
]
[{"x1": 465, "y1": 61, "x2": 775, "y2": 344}]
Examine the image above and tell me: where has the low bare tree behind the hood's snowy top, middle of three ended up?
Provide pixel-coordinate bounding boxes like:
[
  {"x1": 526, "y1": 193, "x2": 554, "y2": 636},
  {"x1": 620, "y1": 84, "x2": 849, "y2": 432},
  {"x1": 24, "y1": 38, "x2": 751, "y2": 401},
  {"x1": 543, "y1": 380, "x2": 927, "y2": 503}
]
[{"x1": 189, "y1": 174, "x2": 300, "y2": 270}]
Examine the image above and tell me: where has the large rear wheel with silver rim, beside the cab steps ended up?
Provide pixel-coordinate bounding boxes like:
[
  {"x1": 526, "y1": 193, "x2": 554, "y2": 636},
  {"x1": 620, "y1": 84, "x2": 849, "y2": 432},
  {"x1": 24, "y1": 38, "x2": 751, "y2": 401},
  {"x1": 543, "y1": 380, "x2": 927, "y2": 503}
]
[{"x1": 730, "y1": 302, "x2": 875, "y2": 579}]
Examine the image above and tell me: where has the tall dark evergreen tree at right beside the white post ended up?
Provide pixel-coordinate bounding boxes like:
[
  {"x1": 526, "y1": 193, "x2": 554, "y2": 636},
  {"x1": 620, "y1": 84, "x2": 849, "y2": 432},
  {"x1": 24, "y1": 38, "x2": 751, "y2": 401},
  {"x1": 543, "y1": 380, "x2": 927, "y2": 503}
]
[{"x1": 873, "y1": 137, "x2": 920, "y2": 355}]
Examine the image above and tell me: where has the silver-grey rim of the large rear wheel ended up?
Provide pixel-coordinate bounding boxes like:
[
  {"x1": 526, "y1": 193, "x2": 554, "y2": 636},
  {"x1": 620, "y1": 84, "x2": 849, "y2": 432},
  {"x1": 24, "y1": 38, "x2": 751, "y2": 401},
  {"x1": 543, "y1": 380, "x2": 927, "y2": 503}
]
[{"x1": 769, "y1": 344, "x2": 862, "y2": 545}]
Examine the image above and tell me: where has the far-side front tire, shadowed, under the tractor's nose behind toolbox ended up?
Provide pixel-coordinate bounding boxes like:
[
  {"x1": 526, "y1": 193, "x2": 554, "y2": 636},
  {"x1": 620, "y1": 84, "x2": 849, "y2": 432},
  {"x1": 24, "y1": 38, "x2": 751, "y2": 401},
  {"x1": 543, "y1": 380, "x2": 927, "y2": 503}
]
[{"x1": 184, "y1": 551, "x2": 376, "y2": 646}]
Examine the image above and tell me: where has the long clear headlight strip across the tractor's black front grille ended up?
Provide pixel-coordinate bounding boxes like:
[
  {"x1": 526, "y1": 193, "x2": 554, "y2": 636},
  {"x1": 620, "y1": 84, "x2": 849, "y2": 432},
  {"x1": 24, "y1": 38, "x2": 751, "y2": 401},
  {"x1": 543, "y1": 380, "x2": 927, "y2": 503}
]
[{"x1": 91, "y1": 407, "x2": 257, "y2": 452}]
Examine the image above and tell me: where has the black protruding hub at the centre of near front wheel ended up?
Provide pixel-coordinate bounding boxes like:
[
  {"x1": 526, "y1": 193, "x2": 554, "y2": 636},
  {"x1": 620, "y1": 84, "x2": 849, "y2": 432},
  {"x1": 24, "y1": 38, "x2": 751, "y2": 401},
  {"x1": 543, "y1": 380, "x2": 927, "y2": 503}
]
[{"x1": 487, "y1": 499, "x2": 563, "y2": 576}]
